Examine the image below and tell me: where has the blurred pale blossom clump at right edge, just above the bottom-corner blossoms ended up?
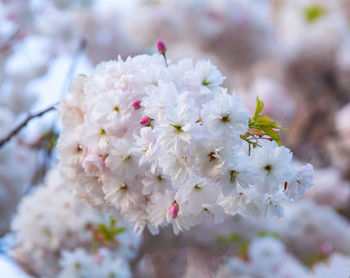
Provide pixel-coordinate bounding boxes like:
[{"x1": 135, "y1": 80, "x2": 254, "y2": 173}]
[{"x1": 272, "y1": 200, "x2": 350, "y2": 264}]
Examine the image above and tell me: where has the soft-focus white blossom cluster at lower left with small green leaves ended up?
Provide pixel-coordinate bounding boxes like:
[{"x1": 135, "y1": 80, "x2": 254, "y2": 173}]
[{"x1": 12, "y1": 169, "x2": 139, "y2": 277}]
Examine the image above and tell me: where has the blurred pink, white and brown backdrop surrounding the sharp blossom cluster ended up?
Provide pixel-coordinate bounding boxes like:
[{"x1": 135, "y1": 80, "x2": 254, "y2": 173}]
[{"x1": 0, "y1": 0, "x2": 350, "y2": 278}]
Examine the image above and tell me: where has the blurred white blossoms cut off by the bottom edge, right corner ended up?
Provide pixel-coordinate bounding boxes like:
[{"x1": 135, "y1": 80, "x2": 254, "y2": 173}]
[{"x1": 215, "y1": 236, "x2": 350, "y2": 278}]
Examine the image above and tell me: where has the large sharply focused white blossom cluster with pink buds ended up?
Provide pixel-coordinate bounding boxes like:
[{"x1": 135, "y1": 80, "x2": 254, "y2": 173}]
[{"x1": 57, "y1": 51, "x2": 312, "y2": 236}]
